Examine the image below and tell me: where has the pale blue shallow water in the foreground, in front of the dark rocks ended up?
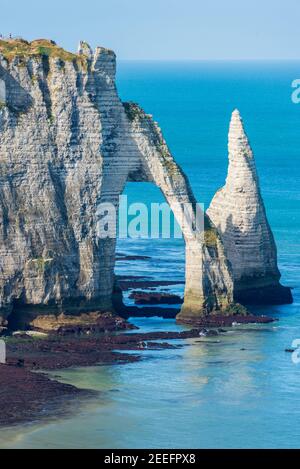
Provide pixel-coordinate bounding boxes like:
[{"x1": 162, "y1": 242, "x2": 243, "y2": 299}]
[{"x1": 0, "y1": 313, "x2": 300, "y2": 448}]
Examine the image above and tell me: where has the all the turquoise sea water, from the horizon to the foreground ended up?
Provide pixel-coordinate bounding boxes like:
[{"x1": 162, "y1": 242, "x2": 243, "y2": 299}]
[{"x1": 0, "y1": 62, "x2": 300, "y2": 448}]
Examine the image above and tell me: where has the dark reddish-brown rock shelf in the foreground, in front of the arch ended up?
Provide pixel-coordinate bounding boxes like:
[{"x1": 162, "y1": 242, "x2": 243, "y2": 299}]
[{"x1": 0, "y1": 315, "x2": 273, "y2": 427}]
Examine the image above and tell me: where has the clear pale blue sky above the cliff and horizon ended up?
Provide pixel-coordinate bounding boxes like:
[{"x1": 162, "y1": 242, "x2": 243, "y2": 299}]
[{"x1": 0, "y1": 0, "x2": 300, "y2": 60}]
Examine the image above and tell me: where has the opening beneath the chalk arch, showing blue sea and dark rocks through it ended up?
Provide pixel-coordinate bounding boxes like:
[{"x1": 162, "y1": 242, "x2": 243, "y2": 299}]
[{"x1": 115, "y1": 182, "x2": 185, "y2": 318}]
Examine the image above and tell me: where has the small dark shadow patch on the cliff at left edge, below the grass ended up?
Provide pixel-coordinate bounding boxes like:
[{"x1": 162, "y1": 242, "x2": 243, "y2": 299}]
[{"x1": 0, "y1": 65, "x2": 33, "y2": 112}]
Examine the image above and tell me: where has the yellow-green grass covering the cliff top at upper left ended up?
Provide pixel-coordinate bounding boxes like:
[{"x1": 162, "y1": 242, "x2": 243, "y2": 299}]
[{"x1": 0, "y1": 39, "x2": 87, "y2": 65}]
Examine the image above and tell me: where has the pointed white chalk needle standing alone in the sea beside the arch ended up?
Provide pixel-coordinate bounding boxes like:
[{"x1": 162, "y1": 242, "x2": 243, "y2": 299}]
[{"x1": 207, "y1": 110, "x2": 292, "y2": 304}]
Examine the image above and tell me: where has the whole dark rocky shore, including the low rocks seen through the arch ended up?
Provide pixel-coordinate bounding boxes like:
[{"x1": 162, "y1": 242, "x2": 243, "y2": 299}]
[{"x1": 0, "y1": 264, "x2": 273, "y2": 427}]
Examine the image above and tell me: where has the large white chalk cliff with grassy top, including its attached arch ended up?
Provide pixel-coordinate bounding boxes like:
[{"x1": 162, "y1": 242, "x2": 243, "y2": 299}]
[{"x1": 0, "y1": 40, "x2": 233, "y2": 325}]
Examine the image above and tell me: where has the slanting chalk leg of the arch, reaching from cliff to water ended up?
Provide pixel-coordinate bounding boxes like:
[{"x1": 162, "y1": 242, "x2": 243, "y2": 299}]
[{"x1": 118, "y1": 103, "x2": 232, "y2": 320}]
